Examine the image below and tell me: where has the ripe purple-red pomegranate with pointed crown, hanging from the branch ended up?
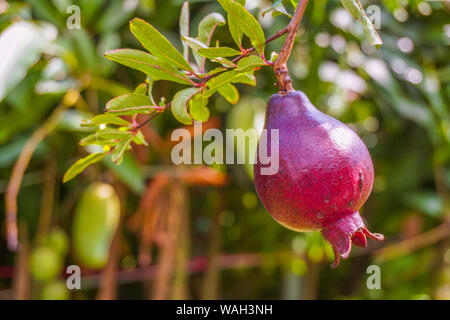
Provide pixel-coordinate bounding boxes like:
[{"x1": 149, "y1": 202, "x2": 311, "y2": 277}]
[{"x1": 254, "y1": 91, "x2": 383, "y2": 268}]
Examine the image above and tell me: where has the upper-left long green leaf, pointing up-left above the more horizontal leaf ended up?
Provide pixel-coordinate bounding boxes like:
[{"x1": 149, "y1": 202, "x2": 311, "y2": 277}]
[{"x1": 130, "y1": 18, "x2": 194, "y2": 72}]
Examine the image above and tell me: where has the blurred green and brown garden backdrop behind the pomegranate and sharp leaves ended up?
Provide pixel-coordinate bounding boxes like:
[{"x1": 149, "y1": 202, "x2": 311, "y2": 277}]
[{"x1": 0, "y1": 0, "x2": 450, "y2": 299}]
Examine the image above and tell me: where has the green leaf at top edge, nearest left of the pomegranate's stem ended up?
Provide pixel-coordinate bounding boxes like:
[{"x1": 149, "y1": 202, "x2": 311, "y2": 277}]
[{"x1": 218, "y1": 0, "x2": 266, "y2": 55}]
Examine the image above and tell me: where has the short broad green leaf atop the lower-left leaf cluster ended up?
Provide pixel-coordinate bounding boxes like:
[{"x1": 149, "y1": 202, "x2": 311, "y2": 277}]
[{"x1": 106, "y1": 93, "x2": 158, "y2": 115}]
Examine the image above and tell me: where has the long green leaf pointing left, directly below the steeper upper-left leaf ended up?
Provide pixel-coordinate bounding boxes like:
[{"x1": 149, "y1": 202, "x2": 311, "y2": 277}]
[{"x1": 105, "y1": 49, "x2": 192, "y2": 84}]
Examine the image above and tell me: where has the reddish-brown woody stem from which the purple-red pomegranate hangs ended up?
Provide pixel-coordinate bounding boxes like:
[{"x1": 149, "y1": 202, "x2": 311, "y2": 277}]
[{"x1": 273, "y1": 0, "x2": 308, "y2": 94}]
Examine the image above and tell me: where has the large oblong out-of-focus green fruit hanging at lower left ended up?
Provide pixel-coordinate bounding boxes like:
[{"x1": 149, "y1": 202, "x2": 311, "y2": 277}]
[{"x1": 72, "y1": 183, "x2": 120, "y2": 269}]
